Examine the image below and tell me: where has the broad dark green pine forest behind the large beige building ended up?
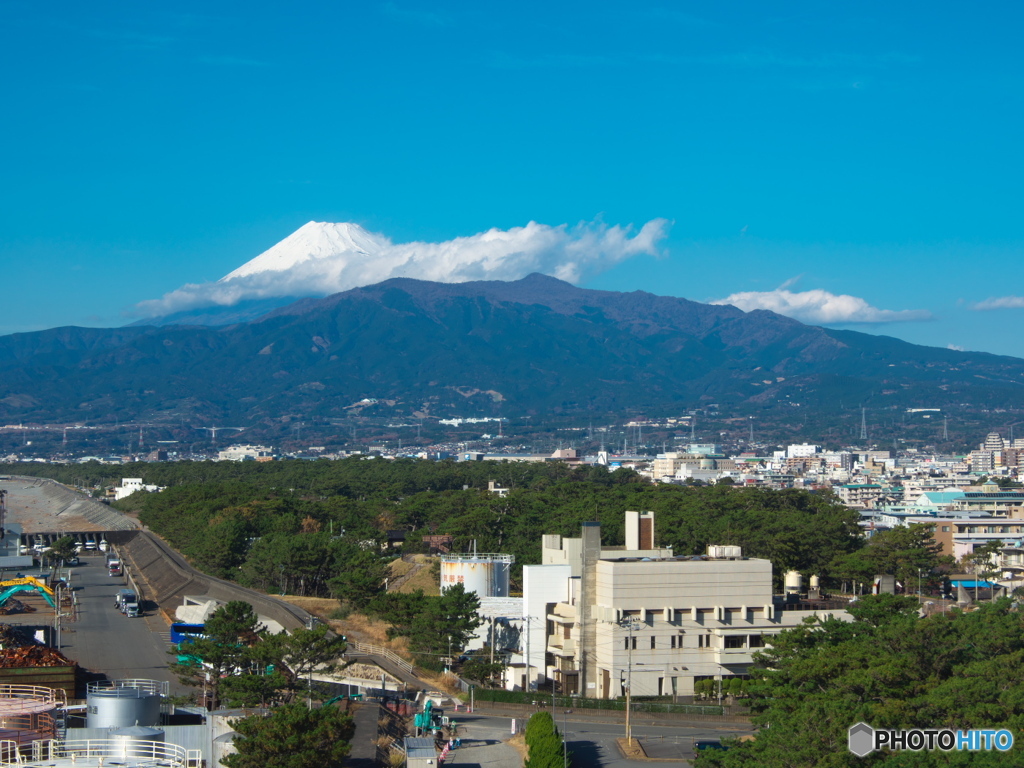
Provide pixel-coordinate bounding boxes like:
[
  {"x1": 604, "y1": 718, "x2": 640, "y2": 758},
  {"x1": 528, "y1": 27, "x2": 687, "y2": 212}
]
[{"x1": 16, "y1": 457, "x2": 862, "y2": 593}]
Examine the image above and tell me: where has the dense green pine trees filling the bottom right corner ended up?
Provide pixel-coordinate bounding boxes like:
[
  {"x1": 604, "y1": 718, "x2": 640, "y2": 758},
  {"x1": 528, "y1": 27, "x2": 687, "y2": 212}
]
[{"x1": 696, "y1": 595, "x2": 1024, "y2": 768}]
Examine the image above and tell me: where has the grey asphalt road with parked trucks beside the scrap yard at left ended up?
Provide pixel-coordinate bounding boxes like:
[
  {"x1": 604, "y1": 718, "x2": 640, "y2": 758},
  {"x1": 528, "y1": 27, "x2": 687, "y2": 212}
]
[{"x1": 0, "y1": 552, "x2": 188, "y2": 693}]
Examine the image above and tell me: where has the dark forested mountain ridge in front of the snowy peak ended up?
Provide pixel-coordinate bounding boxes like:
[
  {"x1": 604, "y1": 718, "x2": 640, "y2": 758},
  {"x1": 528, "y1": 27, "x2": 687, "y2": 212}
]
[{"x1": 0, "y1": 274, "x2": 1024, "y2": 424}]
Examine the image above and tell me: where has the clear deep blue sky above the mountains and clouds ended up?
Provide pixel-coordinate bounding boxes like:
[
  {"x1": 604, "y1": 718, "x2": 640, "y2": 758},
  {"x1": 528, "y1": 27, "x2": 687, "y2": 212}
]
[{"x1": 0, "y1": 0, "x2": 1024, "y2": 356}]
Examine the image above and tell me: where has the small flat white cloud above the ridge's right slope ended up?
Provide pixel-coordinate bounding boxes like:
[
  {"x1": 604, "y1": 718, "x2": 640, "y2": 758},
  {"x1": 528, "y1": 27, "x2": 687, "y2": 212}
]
[{"x1": 711, "y1": 282, "x2": 932, "y2": 326}]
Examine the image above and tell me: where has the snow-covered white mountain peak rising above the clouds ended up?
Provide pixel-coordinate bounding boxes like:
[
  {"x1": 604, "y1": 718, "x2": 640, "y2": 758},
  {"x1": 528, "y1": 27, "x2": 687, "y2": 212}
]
[{"x1": 218, "y1": 221, "x2": 391, "y2": 283}]
